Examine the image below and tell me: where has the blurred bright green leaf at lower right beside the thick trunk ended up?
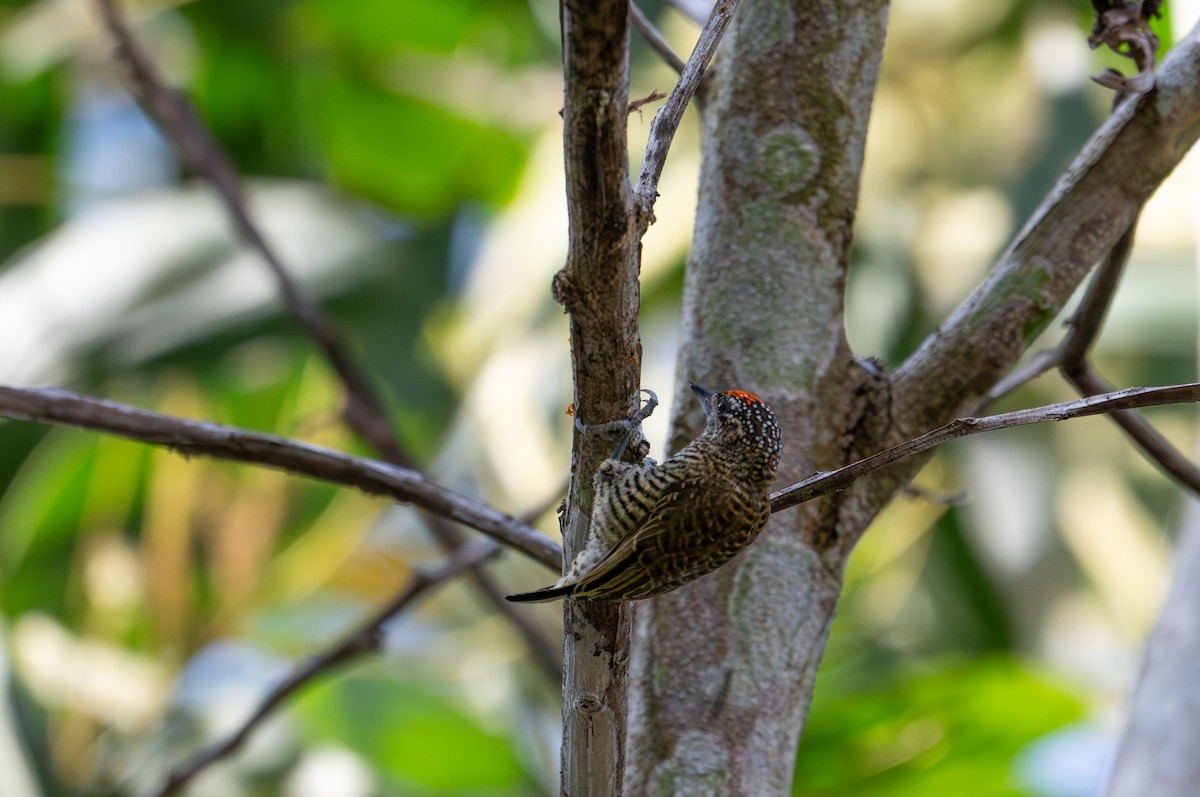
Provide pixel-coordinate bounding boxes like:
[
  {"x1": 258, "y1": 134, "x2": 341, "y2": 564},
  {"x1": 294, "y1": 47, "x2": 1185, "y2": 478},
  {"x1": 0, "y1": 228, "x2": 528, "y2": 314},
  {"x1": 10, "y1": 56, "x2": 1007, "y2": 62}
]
[{"x1": 792, "y1": 658, "x2": 1082, "y2": 797}]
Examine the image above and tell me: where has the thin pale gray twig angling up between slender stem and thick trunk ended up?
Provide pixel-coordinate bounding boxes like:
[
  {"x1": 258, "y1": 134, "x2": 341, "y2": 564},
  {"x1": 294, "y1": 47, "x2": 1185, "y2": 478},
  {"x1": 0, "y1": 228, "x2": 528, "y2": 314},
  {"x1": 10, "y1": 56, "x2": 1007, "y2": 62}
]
[{"x1": 634, "y1": 0, "x2": 738, "y2": 239}]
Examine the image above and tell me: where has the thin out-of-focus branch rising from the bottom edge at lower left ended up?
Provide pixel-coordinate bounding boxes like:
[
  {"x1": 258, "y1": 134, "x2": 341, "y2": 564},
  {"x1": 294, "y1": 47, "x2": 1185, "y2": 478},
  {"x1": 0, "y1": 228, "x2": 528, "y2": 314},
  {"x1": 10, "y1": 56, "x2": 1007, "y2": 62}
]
[{"x1": 142, "y1": 540, "x2": 500, "y2": 797}]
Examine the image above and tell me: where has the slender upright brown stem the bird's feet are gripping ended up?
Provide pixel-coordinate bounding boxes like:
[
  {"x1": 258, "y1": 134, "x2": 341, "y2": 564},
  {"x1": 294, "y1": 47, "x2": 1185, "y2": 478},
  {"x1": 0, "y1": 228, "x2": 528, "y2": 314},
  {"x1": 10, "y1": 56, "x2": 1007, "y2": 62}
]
[{"x1": 553, "y1": 0, "x2": 642, "y2": 797}]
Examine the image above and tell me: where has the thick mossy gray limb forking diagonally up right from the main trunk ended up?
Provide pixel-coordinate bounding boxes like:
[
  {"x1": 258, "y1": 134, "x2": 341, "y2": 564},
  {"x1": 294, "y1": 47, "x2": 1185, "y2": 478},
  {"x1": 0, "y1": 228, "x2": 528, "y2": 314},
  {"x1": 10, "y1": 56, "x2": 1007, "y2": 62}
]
[{"x1": 892, "y1": 17, "x2": 1200, "y2": 429}]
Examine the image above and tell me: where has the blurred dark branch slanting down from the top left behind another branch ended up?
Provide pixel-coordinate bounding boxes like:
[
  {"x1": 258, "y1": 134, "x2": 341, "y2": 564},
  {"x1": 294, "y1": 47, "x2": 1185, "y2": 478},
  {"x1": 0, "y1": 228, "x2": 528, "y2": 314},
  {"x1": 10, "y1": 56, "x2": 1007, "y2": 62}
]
[{"x1": 96, "y1": 0, "x2": 562, "y2": 681}]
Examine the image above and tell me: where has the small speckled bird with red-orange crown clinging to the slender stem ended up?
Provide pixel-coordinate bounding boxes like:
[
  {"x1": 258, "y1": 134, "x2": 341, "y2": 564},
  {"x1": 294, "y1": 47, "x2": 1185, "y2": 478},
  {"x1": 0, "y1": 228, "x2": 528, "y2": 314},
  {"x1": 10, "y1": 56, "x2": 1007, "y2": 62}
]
[{"x1": 509, "y1": 384, "x2": 782, "y2": 603}]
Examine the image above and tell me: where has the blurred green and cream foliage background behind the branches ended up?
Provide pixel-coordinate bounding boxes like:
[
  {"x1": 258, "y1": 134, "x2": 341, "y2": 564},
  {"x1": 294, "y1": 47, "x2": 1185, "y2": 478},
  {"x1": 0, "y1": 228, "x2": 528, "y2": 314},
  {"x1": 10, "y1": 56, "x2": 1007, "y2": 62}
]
[{"x1": 0, "y1": 0, "x2": 1196, "y2": 797}]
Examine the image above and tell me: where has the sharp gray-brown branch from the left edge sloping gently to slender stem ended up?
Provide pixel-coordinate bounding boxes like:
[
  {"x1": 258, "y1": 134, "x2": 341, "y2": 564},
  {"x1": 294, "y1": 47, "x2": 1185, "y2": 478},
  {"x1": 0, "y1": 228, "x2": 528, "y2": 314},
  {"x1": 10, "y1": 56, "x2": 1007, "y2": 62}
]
[{"x1": 0, "y1": 385, "x2": 563, "y2": 571}]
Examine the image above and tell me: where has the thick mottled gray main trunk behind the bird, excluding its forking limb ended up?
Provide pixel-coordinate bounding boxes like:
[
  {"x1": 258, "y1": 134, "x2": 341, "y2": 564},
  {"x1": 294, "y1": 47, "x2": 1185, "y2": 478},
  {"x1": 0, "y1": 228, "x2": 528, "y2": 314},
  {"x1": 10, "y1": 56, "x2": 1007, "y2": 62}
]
[{"x1": 625, "y1": 0, "x2": 886, "y2": 795}]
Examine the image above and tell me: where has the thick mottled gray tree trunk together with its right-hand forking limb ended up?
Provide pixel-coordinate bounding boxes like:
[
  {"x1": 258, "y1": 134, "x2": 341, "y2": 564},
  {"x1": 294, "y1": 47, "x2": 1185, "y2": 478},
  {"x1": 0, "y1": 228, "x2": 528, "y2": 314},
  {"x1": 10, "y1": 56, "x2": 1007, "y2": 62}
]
[{"x1": 624, "y1": 6, "x2": 1200, "y2": 795}]
